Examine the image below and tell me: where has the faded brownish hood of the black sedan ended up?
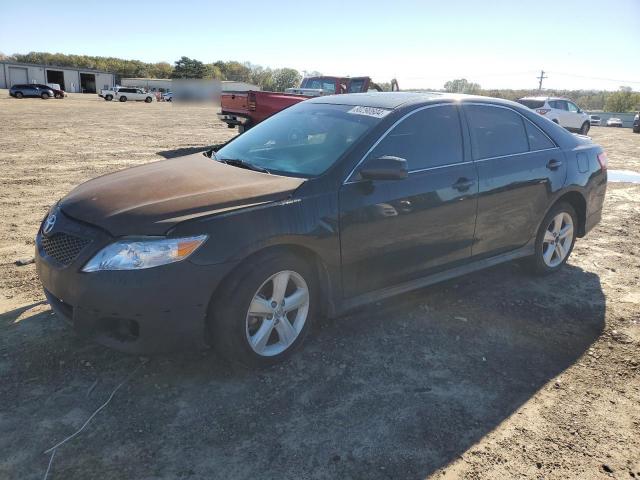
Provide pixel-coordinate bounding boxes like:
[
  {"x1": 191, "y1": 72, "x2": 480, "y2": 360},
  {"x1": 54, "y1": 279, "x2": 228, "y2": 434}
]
[{"x1": 59, "y1": 153, "x2": 304, "y2": 236}]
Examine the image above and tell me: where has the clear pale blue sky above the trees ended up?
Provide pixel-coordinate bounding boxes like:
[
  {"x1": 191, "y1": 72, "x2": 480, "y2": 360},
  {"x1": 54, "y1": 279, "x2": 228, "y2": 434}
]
[{"x1": 0, "y1": 0, "x2": 640, "y2": 90}]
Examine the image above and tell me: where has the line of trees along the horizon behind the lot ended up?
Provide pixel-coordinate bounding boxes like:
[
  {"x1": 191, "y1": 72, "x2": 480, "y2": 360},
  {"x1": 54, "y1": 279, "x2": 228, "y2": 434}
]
[{"x1": 0, "y1": 52, "x2": 640, "y2": 112}]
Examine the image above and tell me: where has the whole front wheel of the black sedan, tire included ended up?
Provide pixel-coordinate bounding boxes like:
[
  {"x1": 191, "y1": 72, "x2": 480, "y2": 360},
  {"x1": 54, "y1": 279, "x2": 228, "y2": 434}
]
[{"x1": 207, "y1": 252, "x2": 318, "y2": 368}]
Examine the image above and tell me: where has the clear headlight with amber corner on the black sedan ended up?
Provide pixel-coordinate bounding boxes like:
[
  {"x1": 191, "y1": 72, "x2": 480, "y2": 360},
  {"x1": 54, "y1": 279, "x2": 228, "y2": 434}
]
[{"x1": 82, "y1": 235, "x2": 207, "y2": 272}]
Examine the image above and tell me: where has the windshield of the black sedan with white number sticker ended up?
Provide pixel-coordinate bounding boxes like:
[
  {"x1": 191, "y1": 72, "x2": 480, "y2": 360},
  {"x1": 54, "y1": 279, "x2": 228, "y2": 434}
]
[{"x1": 216, "y1": 102, "x2": 389, "y2": 177}]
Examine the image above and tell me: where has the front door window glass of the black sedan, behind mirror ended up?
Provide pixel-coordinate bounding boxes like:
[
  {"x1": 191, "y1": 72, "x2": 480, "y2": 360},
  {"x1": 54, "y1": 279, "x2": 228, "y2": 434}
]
[{"x1": 369, "y1": 105, "x2": 463, "y2": 171}]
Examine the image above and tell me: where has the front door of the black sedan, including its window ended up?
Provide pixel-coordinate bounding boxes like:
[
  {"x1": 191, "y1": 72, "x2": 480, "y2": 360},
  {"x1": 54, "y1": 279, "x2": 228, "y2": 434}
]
[{"x1": 340, "y1": 105, "x2": 478, "y2": 297}]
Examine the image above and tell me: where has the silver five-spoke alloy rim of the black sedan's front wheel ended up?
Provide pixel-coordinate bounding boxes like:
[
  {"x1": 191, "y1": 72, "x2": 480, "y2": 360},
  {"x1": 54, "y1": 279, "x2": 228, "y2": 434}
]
[{"x1": 245, "y1": 270, "x2": 309, "y2": 357}]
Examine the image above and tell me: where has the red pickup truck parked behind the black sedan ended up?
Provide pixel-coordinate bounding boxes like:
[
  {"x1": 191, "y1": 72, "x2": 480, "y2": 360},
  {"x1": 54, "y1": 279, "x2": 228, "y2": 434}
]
[{"x1": 218, "y1": 77, "x2": 398, "y2": 133}]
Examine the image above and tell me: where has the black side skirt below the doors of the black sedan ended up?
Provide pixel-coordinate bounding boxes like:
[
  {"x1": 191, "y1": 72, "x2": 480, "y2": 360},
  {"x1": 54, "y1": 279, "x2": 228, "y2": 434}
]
[{"x1": 335, "y1": 242, "x2": 535, "y2": 316}]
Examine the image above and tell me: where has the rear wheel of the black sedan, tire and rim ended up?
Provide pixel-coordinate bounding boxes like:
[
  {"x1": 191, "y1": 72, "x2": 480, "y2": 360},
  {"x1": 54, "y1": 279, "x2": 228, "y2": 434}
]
[{"x1": 526, "y1": 202, "x2": 578, "y2": 275}]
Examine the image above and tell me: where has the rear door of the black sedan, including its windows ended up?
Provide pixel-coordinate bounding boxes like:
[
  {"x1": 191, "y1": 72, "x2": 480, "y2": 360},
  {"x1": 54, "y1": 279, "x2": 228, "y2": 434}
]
[{"x1": 463, "y1": 104, "x2": 567, "y2": 257}]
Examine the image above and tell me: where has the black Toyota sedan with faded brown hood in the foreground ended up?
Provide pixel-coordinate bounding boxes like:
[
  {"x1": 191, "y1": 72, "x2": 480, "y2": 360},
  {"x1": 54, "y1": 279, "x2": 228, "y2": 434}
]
[{"x1": 36, "y1": 93, "x2": 607, "y2": 365}]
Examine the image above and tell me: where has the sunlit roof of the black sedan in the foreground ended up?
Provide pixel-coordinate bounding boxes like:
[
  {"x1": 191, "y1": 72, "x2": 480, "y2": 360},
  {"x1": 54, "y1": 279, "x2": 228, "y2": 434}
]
[{"x1": 304, "y1": 92, "x2": 522, "y2": 110}]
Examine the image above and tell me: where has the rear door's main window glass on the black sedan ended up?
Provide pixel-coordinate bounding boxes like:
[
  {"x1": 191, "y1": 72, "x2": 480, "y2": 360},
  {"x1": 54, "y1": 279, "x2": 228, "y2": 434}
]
[{"x1": 465, "y1": 105, "x2": 529, "y2": 160}]
